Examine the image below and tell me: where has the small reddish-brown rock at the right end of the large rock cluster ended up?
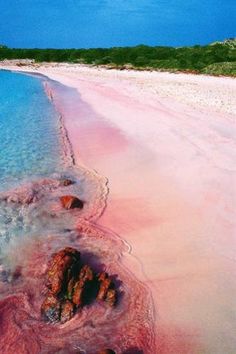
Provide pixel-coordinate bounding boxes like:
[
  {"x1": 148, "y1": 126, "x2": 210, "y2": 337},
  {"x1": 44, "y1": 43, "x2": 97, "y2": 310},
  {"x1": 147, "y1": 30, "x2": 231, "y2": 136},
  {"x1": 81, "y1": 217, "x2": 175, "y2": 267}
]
[{"x1": 97, "y1": 272, "x2": 116, "y2": 306}]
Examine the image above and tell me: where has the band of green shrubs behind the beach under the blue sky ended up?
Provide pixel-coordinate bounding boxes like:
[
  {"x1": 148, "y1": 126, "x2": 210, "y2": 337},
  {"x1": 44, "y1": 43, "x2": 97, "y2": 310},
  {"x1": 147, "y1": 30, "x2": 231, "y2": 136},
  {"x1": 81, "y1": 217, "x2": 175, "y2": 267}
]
[{"x1": 0, "y1": 39, "x2": 236, "y2": 76}]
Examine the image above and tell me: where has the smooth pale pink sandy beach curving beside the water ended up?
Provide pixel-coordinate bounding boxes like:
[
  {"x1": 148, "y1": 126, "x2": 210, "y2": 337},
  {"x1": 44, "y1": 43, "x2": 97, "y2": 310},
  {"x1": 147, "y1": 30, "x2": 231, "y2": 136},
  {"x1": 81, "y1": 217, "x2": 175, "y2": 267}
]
[{"x1": 0, "y1": 66, "x2": 235, "y2": 354}]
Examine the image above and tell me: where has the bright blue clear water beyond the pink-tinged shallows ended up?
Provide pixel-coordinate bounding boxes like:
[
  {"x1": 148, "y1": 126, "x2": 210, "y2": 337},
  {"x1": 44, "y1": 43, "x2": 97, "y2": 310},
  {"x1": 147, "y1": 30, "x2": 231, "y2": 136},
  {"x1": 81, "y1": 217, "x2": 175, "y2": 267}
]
[{"x1": 0, "y1": 70, "x2": 61, "y2": 190}]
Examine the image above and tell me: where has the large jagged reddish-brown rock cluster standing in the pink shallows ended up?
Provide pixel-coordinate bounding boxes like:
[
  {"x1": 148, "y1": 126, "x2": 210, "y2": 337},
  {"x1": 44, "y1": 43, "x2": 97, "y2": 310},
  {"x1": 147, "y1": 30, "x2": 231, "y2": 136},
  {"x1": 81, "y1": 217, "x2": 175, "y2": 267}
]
[{"x1": 41, "y1": 247, "x2": 117, "y2": 323}]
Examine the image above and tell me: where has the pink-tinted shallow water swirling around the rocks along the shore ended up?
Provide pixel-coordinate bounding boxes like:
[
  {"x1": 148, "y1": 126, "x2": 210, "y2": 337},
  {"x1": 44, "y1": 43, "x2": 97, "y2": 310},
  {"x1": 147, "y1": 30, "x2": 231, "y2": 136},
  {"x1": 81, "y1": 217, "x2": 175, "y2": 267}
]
[{"x1": 0, "y1": 68, "x2": 155, "y2": 354}]
